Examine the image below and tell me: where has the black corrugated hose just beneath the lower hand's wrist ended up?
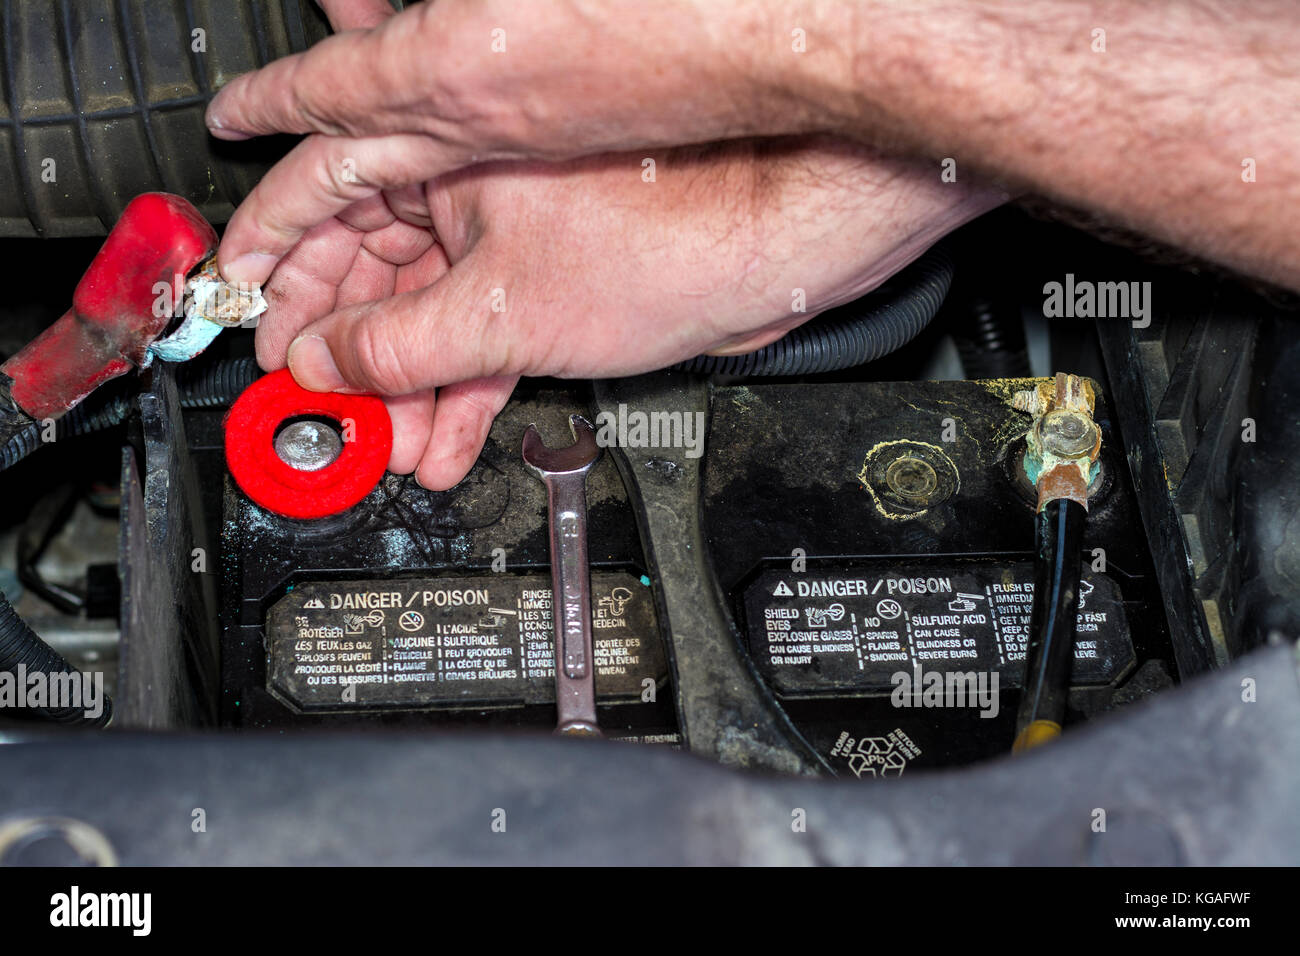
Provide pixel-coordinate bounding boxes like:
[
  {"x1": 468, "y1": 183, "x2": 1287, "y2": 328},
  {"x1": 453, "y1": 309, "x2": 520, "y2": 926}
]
[{"x1": 673, "y1": 246, "x2": 953, "y2": 376}]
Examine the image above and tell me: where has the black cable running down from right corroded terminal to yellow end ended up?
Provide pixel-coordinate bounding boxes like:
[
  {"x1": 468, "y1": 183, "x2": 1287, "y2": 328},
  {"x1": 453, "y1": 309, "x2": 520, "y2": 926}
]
[{"x1": 1015, "y1": 498, "x2": 1088, "y2": 750}]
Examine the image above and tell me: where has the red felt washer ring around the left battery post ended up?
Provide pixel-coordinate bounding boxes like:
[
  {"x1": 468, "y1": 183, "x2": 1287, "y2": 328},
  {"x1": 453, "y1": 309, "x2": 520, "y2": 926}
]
[{"x1": 226, "y1": 368, "x2": 393, "y2": 518}]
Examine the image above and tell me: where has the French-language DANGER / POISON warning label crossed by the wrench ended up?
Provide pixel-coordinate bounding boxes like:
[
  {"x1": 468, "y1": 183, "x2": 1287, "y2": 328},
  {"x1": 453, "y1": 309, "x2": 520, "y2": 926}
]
[{"x1": 267, "y1": 571, "x2": 667, "y2": 711}]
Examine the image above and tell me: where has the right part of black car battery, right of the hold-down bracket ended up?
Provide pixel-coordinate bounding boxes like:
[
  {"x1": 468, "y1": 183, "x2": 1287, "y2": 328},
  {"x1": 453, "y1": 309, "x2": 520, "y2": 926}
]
[{"x1": 703, "y1": 378, "x2": 1173, "y2": 778}]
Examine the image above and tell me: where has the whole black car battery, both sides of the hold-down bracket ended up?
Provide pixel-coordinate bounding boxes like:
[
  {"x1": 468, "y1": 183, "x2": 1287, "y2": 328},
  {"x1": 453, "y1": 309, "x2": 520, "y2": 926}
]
[{"x1": 221, "y1": 380, "x2": 1173, "y2": 779}]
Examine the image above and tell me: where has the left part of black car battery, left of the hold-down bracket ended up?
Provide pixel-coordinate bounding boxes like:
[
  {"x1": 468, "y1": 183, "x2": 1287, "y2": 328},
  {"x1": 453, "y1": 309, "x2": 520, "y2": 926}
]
[{"x1": 221, "y1": 392, "x2": 673, "y2": 739}]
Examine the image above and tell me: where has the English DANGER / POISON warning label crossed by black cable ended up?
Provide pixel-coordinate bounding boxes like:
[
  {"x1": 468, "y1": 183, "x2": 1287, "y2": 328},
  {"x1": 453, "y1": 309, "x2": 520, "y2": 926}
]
[{"x1": 745, "y1": 562, "x2": 1135, "y2": 697}]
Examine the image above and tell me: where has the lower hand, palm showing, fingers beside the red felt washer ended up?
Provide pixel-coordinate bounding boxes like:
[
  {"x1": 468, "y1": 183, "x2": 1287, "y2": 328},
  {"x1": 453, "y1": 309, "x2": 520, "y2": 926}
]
[{"x1": 257, "y1": 139, "x2": 1004, "y2": 489}]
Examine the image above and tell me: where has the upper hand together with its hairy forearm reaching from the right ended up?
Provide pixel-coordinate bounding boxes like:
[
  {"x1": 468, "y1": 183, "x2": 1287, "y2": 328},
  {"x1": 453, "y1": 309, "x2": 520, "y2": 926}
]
[{"x1": 208, "y1": 0, "x2": 1300, "y2": 289}]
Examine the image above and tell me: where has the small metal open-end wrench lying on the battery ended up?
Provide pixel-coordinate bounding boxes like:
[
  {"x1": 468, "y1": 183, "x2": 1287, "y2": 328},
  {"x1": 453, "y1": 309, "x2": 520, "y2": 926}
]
[{"x1": 524, "y1": 415, "x2": 601, "y2": 736}]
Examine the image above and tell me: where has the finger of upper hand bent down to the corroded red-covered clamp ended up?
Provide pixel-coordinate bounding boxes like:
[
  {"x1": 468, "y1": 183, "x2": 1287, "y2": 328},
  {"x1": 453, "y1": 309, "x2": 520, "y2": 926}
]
[{"x1": 217, "y1": 135, "x2": 438, "y2": 285}]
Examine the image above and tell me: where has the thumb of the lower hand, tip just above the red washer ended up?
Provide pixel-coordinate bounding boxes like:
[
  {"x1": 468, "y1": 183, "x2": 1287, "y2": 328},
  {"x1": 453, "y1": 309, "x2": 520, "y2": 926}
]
[{"x1": 287, "y1": 254, "x2": 522, "y2": 395}]
